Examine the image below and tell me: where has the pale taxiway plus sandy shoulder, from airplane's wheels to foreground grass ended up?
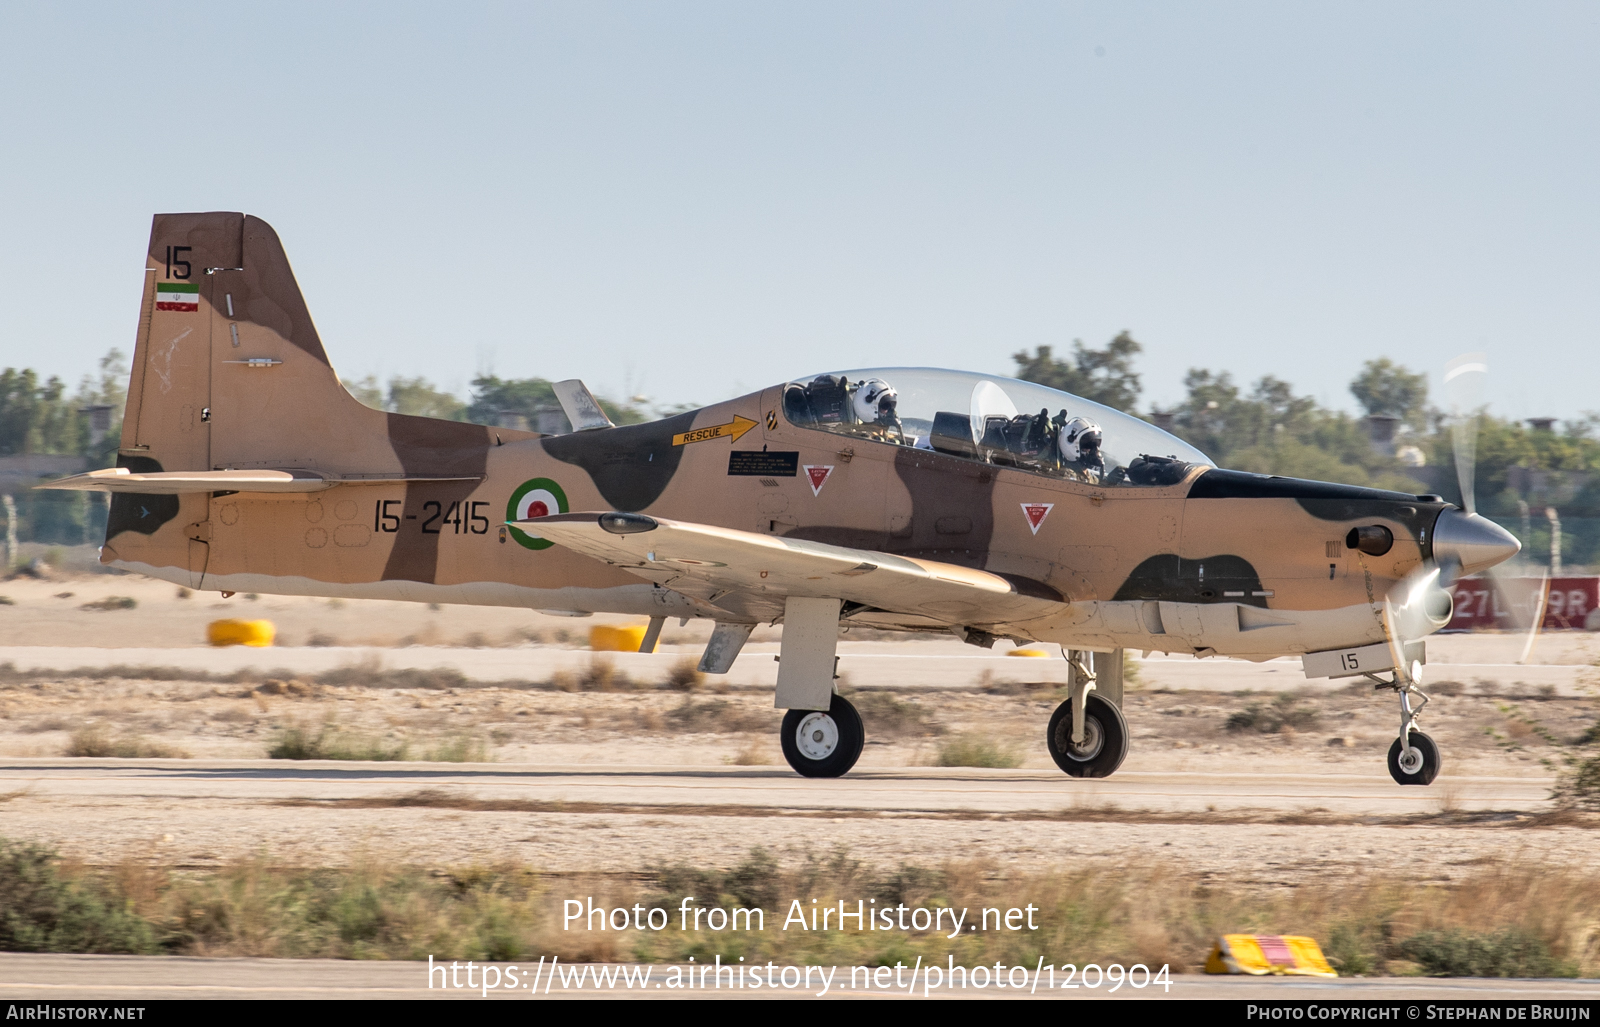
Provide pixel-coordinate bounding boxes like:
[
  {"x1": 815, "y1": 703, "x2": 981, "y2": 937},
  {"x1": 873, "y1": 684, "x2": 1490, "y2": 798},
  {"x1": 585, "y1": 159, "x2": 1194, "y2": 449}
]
[{"x1": 0, "y1": 758, "x2": 1580, "y2": 886}]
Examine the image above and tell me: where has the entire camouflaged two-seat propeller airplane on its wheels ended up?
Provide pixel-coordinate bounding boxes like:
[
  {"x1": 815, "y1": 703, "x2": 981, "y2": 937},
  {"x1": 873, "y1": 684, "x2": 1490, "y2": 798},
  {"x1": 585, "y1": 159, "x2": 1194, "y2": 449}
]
[{"x1": 48, "y1": 213, "x2": 1518, "y2": 784}]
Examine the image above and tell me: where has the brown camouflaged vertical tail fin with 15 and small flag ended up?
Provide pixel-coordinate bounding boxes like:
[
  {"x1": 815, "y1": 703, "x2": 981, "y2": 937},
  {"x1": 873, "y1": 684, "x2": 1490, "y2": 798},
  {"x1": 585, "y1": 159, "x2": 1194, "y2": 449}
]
[{"x1": 101, "y1": 213, "x2": 502, "y2": 582}]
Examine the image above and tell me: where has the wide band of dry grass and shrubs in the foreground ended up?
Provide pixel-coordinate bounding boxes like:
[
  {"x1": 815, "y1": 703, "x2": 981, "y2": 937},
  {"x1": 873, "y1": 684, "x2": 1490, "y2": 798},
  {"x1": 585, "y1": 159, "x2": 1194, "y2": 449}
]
[{"x1": 0, "y1": 840, "x2": 1600, "y2": 976}]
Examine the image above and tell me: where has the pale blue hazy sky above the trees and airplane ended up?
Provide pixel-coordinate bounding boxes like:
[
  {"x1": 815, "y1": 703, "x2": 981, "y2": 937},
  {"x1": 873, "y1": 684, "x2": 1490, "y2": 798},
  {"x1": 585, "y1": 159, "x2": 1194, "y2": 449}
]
[{"x1": 0, "y1": 0, "x2": 1600, "y2": 418}]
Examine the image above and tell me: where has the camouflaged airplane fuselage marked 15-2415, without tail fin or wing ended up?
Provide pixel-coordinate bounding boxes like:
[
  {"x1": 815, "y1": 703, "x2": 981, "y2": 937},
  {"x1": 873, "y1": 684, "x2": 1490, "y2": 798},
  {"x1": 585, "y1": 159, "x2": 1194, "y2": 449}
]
[{"x1": 104, "y1": 376, "x2": 1472, "y2": 659}]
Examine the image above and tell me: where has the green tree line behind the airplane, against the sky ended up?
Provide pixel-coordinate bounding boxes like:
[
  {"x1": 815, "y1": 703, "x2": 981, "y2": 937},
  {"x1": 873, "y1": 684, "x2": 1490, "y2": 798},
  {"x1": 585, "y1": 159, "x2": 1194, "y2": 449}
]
[{"x1": 0, "y1": 343, "x2": 1600, "y2": 563}]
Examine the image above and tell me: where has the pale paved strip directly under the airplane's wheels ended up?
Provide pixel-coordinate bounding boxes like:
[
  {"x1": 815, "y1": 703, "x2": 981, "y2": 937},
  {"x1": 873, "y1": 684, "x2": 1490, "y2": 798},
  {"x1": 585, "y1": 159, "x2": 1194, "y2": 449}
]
[{"x1": 0, "y1": 758, "x2": 1550, "y2": 816}]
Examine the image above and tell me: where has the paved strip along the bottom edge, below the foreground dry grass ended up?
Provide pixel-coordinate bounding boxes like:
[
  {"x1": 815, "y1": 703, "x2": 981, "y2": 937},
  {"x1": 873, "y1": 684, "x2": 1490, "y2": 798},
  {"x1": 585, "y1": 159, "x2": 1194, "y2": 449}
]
[{"x1": 0, "y1": 953, "x2": 1600, "y2": 1003}]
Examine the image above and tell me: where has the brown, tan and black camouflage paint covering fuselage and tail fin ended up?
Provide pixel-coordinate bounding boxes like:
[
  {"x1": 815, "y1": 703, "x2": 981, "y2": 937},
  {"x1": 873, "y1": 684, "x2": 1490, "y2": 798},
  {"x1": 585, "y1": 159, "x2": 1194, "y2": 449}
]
[{"x1": 101, "y1": 213, "x2": 1446, "y2": 659}]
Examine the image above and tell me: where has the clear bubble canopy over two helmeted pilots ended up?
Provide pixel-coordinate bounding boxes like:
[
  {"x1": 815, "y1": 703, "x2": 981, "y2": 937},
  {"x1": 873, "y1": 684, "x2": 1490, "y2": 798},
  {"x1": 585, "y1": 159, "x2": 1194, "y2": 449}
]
[{"x1": 782, "y1": 368, "x2": 1211, "y2": 486}]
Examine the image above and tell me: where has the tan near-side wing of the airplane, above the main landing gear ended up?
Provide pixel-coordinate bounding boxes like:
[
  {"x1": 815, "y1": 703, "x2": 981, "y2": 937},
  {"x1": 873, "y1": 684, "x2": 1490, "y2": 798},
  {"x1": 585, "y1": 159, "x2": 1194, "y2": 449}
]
[{"x1": 509, "y1": 512, "x2": 1062, "y2": 625}]
